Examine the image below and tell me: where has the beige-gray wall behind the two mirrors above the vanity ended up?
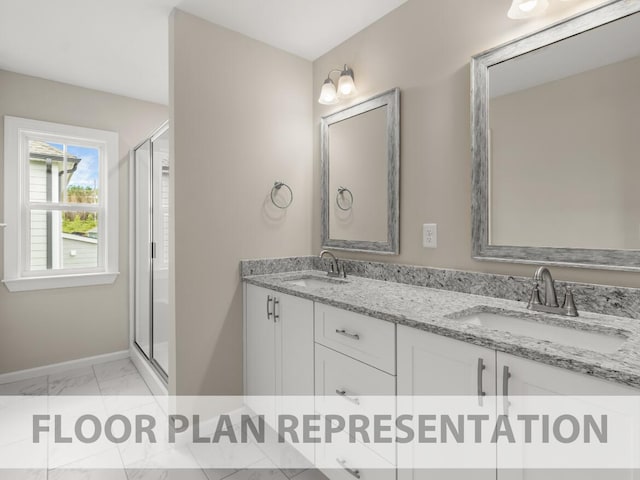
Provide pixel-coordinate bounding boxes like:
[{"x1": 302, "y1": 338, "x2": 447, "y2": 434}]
[{"x1": 312, "y1": 0, "x2": 640, "y2": 287}]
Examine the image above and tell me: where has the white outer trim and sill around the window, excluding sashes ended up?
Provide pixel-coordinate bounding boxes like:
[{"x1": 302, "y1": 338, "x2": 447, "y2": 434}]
[{"x1": 3, "y1": 116, "x2": 119, "y2": 292}]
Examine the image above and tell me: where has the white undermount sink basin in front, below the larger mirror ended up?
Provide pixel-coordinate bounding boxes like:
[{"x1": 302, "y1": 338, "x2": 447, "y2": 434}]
[{"x1": 456, "y1": 312, "x2": 627, "y2": 353}]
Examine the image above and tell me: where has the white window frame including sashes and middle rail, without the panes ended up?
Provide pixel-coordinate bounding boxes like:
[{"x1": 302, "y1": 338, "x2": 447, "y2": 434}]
[{"x1": 3, "y1": 116, "x2": 119, "y2": 292}]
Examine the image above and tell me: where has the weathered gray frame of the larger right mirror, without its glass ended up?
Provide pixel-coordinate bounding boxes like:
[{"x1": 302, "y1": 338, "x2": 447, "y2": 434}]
[{"x1": 471, "y1": 0, "x2": 640, "y2": 271}]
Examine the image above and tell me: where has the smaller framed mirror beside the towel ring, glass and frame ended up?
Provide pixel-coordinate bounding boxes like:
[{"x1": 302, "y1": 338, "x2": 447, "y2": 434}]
[{"x1": 320, "y1": 88, "x2": 400, "y2": 255}]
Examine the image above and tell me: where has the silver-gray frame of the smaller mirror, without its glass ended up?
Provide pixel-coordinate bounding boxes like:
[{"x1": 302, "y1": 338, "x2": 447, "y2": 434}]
[{"x1": 320, "y1": 88, "x2": 400, "y2": 255}]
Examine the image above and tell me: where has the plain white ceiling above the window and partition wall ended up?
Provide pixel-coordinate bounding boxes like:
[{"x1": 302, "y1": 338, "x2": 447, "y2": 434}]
[{"x1": 0, "y1": 0, "x2": 407, "y2": 104}]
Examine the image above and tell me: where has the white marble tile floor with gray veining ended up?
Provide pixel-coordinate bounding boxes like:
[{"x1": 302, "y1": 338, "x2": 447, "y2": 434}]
[{"x1": 0, "y1": 359, "x2": 326, "y2": 480}]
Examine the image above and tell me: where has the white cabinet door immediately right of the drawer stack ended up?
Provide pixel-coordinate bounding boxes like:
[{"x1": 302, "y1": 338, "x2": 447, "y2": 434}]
[{"x1": 397, "y1": 326, "x2": 496, "y2": 480}]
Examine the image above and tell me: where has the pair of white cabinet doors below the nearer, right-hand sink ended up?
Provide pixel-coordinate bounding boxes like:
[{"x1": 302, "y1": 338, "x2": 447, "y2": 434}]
[{"x1": 398, "y1": 326, "x2": 640, "y2": 480}]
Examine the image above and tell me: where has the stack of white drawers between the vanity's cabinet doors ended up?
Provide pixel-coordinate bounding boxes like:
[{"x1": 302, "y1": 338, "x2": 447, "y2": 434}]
[{"x1": 314, "y1": 303, "x2": 396, "y2": 480}]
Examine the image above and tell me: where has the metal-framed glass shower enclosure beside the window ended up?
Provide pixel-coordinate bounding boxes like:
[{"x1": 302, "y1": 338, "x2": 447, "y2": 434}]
[{"x1": 131, "y1": 122, "x2": 170, "y2": 383}]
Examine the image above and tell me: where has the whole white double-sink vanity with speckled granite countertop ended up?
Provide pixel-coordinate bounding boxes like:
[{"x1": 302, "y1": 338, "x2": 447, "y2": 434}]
[{"x1": 244, "y1": 256, "x2": 640, "y2": 480}]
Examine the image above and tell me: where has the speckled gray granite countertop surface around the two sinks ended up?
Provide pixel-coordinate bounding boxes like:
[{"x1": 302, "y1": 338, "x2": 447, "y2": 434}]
[{"x1": 243, "y1": 270, "x2": 640, "y2": 388}]
